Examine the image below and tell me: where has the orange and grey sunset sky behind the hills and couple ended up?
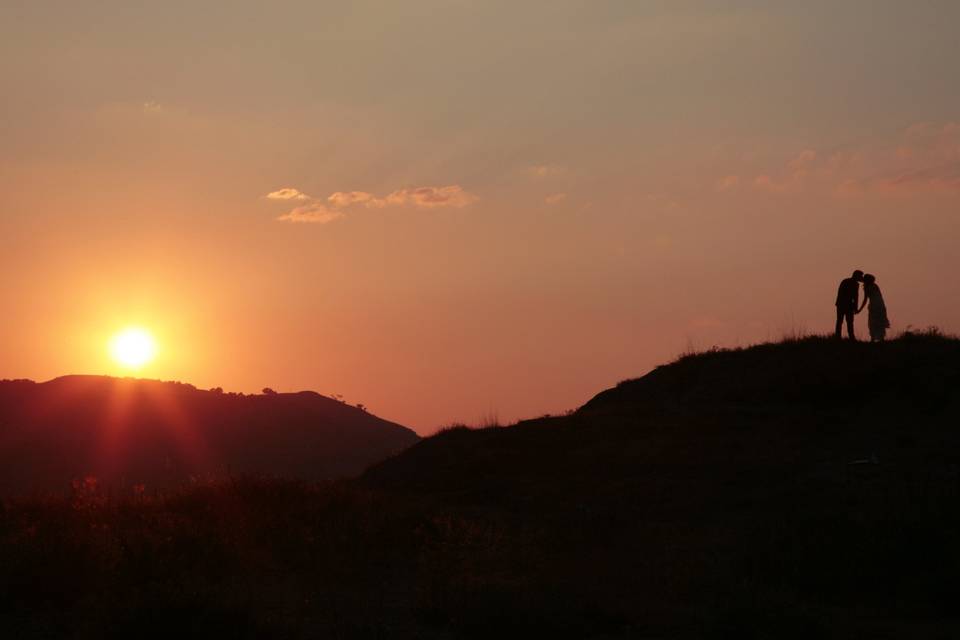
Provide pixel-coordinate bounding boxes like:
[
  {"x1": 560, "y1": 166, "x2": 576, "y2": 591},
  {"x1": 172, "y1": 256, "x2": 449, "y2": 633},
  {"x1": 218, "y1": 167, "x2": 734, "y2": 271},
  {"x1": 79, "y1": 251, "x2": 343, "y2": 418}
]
[{"x1": 0, "y1": 0, "x2": 960, "y2": 434}]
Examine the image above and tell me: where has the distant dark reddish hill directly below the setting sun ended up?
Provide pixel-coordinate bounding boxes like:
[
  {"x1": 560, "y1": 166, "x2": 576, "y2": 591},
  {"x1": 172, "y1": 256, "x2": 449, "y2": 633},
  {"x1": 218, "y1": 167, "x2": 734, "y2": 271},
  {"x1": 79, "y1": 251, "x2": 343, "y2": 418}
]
[{"x1": 0, "y1": 376, "x2": 419, "y2": 494}]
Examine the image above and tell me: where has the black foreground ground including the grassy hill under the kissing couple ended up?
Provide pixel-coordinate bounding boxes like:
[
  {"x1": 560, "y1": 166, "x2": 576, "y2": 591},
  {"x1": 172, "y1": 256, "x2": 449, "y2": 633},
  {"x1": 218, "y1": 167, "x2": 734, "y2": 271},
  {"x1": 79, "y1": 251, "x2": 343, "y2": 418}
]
[{"x1": 0, "y1": 334, "x2": 960, "y2": 638}]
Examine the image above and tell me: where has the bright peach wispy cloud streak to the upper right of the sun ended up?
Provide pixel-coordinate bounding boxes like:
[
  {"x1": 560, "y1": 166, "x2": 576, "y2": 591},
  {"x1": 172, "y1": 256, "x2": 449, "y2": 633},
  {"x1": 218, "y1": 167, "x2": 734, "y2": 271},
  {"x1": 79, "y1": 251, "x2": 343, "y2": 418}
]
[{"x1": 266, "y1": 184, "x2": 479, "y2": 223}]
